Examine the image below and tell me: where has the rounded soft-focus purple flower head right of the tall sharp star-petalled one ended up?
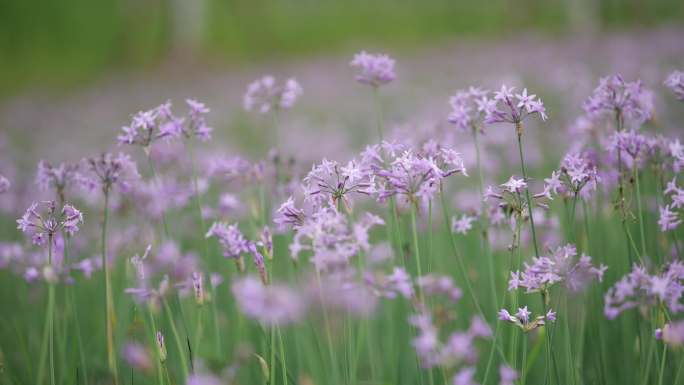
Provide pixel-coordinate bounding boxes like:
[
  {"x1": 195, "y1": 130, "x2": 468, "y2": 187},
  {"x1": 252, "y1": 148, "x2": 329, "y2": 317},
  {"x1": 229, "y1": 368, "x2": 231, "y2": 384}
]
[{"x1": 584, "y1": 75, "x2": 653, "y2": 123}]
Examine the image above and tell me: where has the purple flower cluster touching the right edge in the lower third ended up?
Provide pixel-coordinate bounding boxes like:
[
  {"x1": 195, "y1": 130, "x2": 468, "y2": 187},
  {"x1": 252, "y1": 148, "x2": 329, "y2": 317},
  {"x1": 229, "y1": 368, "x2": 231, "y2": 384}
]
[{"x1": 604, "y1": 261, "x2": 684, "y2": 319}]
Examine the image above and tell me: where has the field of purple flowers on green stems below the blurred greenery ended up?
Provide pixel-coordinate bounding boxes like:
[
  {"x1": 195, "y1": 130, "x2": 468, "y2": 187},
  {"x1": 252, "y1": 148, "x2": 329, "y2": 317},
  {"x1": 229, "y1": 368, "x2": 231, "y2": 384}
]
[{"x1": 0, "y1": 25, "x2": 684, "y2": 385}]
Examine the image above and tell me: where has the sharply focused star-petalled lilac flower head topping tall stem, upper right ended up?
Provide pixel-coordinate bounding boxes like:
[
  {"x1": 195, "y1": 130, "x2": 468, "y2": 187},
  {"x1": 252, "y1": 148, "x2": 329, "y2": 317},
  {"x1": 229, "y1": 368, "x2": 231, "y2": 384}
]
[{"x1": 480, "y1": 85, "x2": 548, "y2": 125}]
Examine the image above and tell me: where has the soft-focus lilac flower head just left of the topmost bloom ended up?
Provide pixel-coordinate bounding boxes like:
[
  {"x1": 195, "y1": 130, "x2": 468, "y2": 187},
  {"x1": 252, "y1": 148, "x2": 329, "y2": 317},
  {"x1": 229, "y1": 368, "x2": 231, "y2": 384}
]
[{"x1": 242, "y1": 75, "x2": 302, "y2": 114}]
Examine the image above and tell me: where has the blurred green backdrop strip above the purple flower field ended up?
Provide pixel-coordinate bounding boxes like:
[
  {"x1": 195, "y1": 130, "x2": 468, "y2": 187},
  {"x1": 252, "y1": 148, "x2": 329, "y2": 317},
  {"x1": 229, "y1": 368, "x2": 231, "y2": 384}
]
[{"x1": 0, "y1": 0, "x2": 684, "y2": 97}]
